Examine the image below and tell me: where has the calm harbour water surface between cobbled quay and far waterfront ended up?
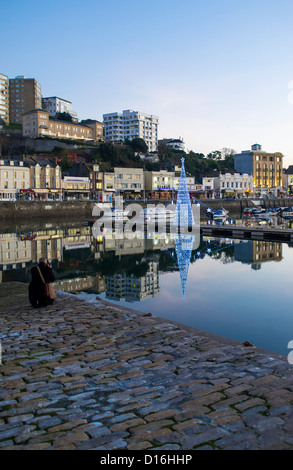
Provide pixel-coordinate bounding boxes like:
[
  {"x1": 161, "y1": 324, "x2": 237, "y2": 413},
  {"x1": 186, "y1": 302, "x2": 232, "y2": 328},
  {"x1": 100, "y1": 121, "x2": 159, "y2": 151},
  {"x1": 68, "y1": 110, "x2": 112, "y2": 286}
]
[{"x1": 0, "y1": 223, "x2": 293, "y2": 355}]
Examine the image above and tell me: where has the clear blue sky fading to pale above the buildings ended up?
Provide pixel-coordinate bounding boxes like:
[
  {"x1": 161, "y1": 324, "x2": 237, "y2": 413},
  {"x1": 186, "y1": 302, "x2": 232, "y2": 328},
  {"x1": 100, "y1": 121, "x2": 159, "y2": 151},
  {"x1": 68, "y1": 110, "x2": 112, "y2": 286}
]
[{"x1": 0, "y1": 0, "x2": 293, "y2": 167}]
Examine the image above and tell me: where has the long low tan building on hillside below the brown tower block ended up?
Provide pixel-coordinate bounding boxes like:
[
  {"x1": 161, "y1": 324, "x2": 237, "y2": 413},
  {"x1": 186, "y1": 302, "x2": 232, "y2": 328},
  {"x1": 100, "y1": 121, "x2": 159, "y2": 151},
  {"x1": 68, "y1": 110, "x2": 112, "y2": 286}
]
[{"x1": 22, "y1": 109, "x2": 100, "y2": 142}]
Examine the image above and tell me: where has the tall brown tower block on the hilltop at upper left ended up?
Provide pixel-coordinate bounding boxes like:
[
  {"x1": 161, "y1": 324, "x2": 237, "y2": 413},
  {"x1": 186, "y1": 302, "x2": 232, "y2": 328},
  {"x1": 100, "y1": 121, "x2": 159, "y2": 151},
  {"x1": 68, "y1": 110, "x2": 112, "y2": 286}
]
[{"x1": 9, "y1": 76, "x2": 42, "y2": 124}]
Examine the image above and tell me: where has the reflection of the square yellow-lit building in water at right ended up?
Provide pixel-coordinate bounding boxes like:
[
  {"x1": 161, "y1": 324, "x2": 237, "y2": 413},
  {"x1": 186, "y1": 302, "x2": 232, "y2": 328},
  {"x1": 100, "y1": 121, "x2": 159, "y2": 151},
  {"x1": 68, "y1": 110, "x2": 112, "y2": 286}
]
[{"x1": 234, "y1": 240, "x2": 282, "y2": 270}]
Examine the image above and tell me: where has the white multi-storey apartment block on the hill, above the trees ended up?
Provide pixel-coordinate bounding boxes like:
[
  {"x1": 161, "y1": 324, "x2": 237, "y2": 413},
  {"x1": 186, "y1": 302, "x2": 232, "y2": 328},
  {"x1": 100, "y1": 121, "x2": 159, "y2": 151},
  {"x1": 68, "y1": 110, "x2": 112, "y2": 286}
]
[{"x1": 103, "y1": 109, "x2": 159, "y2": 152}]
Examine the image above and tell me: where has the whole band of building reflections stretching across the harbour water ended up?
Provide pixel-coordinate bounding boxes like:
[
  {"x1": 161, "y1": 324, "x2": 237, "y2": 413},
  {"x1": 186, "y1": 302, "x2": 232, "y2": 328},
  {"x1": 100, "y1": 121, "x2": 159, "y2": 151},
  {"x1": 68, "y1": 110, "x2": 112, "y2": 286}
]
[{"x1": 0, "y1": 224, "x2": 282, "y2": 302}]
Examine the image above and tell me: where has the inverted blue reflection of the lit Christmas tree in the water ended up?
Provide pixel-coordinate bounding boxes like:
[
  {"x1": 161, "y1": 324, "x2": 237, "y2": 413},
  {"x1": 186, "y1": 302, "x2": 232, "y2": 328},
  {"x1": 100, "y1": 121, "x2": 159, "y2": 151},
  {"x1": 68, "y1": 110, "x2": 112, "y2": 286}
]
[{"x1": 174, "y1": 234, "x2": 194, "y2": 299}]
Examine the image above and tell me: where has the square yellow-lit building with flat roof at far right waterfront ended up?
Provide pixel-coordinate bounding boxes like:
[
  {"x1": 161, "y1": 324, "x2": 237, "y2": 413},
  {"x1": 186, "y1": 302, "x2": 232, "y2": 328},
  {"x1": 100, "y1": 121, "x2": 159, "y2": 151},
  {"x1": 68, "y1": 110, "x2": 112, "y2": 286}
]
[{"x1": 234, "y1": 144, "x2": 283, "y2": 195}]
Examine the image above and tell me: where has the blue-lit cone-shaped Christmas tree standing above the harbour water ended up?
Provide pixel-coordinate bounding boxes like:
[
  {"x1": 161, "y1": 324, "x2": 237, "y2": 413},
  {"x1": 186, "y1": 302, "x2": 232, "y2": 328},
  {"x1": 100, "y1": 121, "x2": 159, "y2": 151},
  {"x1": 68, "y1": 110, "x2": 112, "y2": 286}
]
[{"x1": 174, "y1": 158, "x2": 194, "y2": 227}]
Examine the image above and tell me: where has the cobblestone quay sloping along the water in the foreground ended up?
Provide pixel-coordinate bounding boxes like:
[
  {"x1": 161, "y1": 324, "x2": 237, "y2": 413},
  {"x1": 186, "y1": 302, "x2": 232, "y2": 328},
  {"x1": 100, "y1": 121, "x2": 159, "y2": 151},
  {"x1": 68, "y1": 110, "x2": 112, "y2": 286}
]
[{"x1": 0, "y1": 283, "x2": 293, "y2": 451}]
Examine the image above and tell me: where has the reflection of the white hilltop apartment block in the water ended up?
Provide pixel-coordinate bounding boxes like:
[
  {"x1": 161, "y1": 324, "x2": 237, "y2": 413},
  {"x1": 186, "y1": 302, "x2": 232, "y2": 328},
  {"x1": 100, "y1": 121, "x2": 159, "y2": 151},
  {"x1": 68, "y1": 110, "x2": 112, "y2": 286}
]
[{"x1": 106, "y1": 261, "x2": 160, "y2": 302}]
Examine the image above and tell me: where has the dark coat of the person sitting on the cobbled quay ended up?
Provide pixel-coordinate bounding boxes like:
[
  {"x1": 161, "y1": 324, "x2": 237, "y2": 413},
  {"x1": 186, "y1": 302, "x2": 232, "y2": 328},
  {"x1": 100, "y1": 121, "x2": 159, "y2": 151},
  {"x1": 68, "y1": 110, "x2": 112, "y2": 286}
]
[{"x1": 28, "y1": 263, "x2": 55, "y2": 308}]
